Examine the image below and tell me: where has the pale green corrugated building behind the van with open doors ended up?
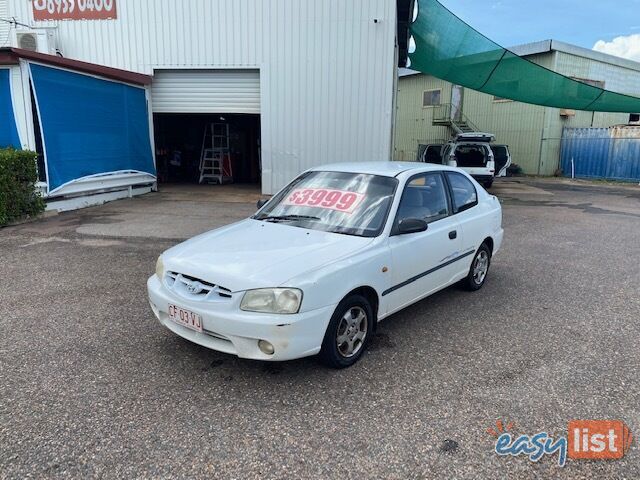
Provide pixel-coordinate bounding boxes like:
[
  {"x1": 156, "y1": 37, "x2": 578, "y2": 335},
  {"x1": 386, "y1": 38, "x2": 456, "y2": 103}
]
[{"x1": 394, "y1": 40, "x2": 640, "y2": 175}]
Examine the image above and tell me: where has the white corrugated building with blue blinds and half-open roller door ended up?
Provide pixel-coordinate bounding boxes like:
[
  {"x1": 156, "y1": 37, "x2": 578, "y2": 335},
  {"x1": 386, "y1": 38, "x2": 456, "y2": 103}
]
[{"x1": 0, "y1": 0, "x2": 412, "y2": 209}]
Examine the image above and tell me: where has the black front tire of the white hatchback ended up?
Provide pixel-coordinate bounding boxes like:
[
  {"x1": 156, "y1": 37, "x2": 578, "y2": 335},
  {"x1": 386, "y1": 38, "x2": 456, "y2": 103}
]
[{"x1": 319, "y1": 295, "x2": 376, "y2": 368}]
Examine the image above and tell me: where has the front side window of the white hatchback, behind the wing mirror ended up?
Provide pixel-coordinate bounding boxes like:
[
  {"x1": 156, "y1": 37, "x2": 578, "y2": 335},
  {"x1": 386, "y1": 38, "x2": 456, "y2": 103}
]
[{"x1": 396, "y1": 173, "x2": 449, "y2": 225}]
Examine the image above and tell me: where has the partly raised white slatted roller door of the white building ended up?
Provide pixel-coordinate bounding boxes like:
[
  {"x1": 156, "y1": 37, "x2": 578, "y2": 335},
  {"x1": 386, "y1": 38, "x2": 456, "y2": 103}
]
[{"x1": 151, "y1": 69, "x2": 260, "y2": 113}]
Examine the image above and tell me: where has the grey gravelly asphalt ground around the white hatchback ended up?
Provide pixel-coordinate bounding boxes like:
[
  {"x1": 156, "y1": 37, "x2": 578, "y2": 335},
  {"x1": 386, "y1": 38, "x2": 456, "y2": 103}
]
[{"x1": 0, "y1": 179, "x2": 640, "y2": 479}]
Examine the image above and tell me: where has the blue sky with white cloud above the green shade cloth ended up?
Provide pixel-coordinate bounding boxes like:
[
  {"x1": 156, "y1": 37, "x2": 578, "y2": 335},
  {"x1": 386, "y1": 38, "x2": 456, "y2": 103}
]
[{"x1": 440, "y1": 0, "x2": 640, "y2": 61}]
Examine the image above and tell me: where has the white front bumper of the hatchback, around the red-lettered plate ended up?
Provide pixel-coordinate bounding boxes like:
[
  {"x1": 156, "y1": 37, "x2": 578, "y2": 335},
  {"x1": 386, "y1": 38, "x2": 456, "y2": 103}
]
[{"x1": 147, "y1": 275, "x2": 336, "y2": 361}]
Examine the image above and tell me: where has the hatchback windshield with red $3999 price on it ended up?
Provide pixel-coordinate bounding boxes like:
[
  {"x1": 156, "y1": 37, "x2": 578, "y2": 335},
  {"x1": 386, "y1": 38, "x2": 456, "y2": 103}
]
[{"x1": 252, "y1": 172, "x2": 398, "y2": 237}]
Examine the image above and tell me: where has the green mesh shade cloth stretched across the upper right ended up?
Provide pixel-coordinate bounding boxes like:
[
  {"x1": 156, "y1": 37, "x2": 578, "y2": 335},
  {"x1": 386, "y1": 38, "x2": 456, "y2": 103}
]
[{"x1": 409, "y1": 0, "x2": 640, "y2": 113}]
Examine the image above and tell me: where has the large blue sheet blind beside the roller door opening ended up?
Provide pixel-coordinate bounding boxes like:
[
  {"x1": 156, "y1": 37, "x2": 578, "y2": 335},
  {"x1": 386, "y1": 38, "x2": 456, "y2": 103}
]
[{"x1": 31, "y1": 64, "x2": 156, "y2": 192}]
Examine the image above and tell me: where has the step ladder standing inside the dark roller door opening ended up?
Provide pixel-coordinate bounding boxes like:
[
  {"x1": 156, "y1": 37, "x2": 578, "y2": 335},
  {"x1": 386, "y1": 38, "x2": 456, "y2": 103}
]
[{"x1": 199, "y1": 123, "x2": 233, "y2": 185}]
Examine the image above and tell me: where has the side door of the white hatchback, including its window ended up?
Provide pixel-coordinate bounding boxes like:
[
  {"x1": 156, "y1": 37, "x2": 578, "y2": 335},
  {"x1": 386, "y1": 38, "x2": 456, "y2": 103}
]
[{"x1": 383, "y1": 172, "x2": 461, "y2": 313}]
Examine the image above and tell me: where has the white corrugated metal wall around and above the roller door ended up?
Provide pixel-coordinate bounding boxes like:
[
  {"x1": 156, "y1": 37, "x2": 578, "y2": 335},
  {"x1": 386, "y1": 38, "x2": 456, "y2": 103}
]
[{"x1": 6, "y1": 0, "x2": 396, "y2": 193}]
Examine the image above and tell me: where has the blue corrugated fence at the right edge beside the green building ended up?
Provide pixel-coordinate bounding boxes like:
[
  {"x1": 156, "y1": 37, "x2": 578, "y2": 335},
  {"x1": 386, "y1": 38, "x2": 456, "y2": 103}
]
[{"x1": 560, "y1": 126, "x2": 640, "y2": 181}]
